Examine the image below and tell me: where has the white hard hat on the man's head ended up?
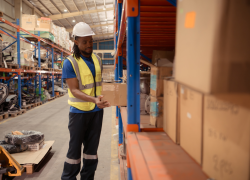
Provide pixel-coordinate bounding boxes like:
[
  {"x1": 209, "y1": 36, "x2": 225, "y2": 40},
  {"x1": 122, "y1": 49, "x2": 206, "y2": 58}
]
[{"x1": 72, "y1": 22, "x2": 95, "y2": 37}]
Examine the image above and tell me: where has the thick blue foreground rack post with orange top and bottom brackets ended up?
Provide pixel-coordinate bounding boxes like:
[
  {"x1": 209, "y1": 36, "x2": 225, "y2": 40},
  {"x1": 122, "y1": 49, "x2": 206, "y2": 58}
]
[{"x1": 126, "y1": 0, "x2": 140, "y2": 180}]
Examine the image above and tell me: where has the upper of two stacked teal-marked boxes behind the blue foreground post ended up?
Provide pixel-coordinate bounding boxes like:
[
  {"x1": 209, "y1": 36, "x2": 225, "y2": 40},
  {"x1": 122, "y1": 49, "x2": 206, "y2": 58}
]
[{"x1": 150, "y1": 66, "x2": 173, "y2": 97}]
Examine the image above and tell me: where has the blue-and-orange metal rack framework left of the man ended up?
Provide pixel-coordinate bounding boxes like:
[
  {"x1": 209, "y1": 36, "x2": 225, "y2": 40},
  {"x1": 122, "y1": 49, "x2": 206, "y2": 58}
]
[{"x1": 0, "y1": 17, "x2": 71, "y2": 108}]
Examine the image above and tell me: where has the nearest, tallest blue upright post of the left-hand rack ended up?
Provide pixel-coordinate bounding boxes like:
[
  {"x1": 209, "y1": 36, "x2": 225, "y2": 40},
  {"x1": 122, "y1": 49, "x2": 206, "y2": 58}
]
[{"x1": 16, "y1": 19, "x2": 22, "y2": 109}]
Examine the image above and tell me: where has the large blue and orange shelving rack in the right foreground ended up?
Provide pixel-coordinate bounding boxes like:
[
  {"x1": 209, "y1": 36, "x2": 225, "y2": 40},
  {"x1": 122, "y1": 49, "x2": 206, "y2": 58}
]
[{"x1": 114, "y1": 0, "x2": 202, "y2": 180}]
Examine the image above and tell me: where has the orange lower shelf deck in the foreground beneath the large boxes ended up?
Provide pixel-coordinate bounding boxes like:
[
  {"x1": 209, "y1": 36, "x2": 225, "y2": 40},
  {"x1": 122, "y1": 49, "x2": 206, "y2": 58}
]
[{"x1": 127, "y1": 132, "x2": 208, "y2": 180}]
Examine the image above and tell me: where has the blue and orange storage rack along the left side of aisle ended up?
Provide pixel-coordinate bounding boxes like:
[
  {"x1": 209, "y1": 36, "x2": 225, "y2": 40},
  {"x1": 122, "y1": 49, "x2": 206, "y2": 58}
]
[{"x1": 0, "y1": 17, "x2": 68, "y2": 108}]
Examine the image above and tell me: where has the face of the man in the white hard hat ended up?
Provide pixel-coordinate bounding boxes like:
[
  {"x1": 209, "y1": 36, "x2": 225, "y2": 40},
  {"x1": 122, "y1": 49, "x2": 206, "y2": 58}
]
[{"x1": 75, "y1": 36, "x2": 93, "y2": 56}]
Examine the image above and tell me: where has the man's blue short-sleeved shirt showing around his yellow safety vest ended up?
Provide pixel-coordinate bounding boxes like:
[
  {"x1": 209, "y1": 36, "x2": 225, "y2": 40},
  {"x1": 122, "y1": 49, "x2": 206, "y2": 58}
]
[{"x1": 62, "y1": 55, "x2": 102, "y2": 113}]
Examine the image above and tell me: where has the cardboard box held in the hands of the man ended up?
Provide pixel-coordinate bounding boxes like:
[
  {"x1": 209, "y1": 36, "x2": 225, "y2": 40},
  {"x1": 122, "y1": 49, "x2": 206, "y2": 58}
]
[{"x1": 102, "y1": 83, "x2": 127, "y2": 106}]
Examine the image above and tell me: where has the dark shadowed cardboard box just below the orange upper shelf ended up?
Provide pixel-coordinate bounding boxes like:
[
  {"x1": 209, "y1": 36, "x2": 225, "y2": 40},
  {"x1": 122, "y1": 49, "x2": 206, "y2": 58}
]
[{"x1": 152, "y1": 50, "x2": 175, "y2": 66}]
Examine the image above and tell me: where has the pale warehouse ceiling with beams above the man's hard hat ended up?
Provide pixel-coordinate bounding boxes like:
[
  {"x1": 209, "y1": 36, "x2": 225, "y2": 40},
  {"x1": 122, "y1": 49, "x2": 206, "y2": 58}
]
[{"x1": 28, "y1": 0, "x2": 114, "y2": 41}]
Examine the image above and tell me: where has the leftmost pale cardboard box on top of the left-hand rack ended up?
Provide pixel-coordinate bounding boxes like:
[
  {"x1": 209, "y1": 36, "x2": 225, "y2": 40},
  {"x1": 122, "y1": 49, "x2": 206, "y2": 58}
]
[{"x1": 21, "y1": 14, "x2": 38, "y2": 31}]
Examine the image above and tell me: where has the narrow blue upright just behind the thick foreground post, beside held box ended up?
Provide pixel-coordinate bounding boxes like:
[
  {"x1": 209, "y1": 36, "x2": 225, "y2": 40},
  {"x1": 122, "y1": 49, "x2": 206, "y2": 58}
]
[{"x1": 116, "y1": 1, "x2": 123, "y2": 145}]
